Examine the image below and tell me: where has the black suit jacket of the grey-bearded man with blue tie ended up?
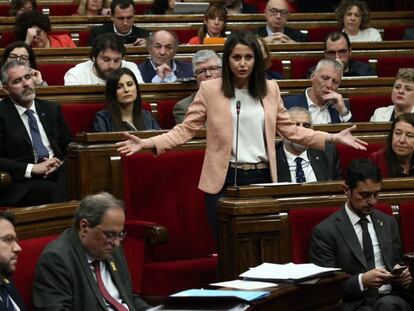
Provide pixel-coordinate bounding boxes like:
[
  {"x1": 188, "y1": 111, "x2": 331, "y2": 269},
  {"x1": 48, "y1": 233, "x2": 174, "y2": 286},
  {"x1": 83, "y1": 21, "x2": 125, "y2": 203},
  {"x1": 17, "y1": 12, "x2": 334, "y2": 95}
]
[{"x1": 0, "y1": 97, "x2": 71, "y2": 202}]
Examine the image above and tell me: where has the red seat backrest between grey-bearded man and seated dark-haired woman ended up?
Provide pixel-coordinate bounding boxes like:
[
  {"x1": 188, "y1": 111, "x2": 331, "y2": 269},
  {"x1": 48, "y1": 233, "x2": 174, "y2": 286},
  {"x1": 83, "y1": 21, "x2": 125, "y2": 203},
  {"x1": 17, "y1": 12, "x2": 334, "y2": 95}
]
[{"x1": 62, "y1": 103, "x2": 104, "y2": 135}]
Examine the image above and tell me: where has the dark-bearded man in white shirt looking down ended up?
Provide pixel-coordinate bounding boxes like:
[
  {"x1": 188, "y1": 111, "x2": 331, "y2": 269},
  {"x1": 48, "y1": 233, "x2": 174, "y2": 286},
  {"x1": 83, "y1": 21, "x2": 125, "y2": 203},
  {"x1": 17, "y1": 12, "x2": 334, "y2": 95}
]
[{"x1": 65, "y1": 33, "x2": 144, "y2": 85}]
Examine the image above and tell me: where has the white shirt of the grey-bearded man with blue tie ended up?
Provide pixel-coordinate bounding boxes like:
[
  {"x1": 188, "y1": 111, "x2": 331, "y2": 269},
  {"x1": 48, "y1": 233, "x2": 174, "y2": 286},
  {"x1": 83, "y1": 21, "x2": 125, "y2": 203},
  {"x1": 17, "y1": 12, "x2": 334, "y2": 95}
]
[{"x1": 14, "y1": 102, "x2": 54, "y2": 178}]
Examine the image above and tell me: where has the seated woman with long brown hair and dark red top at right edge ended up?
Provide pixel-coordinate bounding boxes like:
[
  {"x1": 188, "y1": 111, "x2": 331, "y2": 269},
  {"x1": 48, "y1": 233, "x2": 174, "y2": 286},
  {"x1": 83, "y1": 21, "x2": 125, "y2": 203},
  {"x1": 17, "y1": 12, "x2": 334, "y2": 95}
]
[{"x1": 369, "y1": 113, "x2": 414, "y2": 177}]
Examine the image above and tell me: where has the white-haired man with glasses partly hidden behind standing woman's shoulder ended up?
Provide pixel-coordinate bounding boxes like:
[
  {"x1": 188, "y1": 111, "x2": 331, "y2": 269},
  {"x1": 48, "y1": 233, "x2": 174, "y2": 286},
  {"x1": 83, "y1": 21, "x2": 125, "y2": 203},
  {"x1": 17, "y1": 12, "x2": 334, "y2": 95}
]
[{"x1": 173, "y1": 50, "x2": 221, "y2": 124}]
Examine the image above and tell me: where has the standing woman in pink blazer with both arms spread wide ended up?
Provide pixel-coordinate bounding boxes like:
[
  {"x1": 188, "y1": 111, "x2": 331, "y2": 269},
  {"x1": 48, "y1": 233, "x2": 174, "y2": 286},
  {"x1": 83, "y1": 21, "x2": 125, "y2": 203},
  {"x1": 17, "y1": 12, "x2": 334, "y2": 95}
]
[{"x1": 117, "y1": 32, "x2": 366, "y2": 236}]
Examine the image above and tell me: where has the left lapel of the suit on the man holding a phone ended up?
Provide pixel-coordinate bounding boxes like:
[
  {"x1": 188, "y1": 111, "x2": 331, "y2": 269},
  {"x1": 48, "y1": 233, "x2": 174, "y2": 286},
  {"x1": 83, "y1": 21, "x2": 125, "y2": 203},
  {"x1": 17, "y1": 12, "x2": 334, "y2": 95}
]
[{"x1": 337, "y1": 207, "x2": 367, "y2": 268}]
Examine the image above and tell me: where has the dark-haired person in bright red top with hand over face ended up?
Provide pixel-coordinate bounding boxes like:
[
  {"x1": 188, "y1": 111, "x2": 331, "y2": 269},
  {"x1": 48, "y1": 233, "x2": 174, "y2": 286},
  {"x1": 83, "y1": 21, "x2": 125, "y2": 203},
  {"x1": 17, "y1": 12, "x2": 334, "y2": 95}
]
[{"x1": 14, "y1": 11, "x2": 76, "y2": 48}]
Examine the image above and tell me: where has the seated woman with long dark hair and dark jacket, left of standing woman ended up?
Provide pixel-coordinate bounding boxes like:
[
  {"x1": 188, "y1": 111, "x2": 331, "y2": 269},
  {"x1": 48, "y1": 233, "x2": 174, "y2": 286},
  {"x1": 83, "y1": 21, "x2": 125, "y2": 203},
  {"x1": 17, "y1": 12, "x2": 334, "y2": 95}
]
[{"x1": 94, "y1": 68, "x2": 160, "y2": 132}]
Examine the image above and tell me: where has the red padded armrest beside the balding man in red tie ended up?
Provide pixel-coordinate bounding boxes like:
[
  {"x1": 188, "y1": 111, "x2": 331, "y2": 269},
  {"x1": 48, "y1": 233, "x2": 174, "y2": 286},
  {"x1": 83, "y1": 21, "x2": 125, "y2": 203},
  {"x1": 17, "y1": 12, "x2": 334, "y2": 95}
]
[{"x1": 125, "y1": 220, "x2": 168, "y2": 246}]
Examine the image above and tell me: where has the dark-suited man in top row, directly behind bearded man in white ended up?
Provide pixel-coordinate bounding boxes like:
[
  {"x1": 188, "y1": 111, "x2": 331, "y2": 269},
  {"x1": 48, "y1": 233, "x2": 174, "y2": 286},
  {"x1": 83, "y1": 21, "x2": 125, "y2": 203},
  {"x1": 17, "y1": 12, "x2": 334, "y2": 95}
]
[{"x1": 88, "y1": 0, "x2": 149, "y2": 46}]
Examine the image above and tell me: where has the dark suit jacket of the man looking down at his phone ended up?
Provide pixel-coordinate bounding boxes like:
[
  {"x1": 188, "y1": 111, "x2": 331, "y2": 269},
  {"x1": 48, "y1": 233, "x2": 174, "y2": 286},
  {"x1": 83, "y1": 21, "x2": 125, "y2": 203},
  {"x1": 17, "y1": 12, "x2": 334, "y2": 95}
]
[{"x1": 309, "y1": 208, "x2": 402, "y2": 311}]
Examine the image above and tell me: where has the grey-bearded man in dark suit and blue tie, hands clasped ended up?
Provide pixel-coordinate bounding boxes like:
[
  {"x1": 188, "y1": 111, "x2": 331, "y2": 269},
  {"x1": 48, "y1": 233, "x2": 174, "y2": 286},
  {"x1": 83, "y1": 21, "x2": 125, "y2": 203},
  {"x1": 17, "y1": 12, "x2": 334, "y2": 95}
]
[{"x1": 0, "y1": 60, "x2": 71, "y2": 206}]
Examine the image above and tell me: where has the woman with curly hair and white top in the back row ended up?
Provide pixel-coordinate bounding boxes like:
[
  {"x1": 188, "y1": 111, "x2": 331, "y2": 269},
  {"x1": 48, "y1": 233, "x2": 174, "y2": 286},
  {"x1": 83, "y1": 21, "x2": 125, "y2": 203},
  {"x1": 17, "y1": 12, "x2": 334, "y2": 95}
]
[{"x1": 336, "y1": 0, "x2": 382, "y2": 42}]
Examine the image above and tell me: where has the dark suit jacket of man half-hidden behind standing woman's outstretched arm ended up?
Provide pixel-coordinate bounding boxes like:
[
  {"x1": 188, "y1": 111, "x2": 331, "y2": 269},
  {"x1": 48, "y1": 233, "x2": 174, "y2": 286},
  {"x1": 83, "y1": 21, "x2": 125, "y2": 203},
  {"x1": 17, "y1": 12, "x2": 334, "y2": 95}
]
[{"x1": 276, "y1": 142, "x2": 342, "y2": 182}]
